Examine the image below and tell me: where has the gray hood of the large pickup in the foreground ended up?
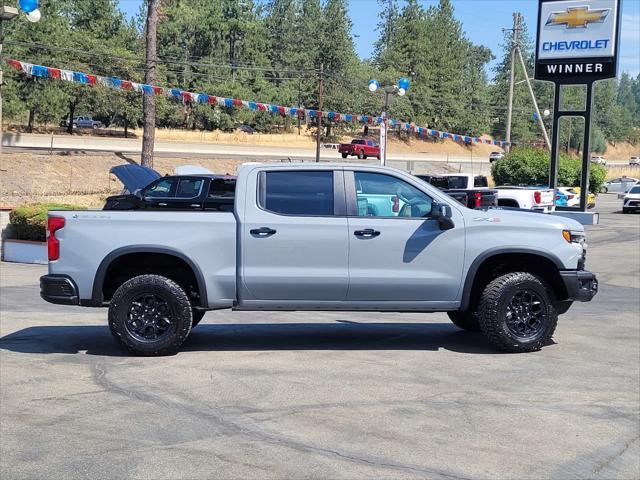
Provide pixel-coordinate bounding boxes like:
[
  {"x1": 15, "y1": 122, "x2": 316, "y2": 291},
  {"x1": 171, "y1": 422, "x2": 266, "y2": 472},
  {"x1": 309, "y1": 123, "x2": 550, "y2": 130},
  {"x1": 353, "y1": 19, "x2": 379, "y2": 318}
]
[{"x1": 469, "y1": 208, "x2": 584, "y2": 232}]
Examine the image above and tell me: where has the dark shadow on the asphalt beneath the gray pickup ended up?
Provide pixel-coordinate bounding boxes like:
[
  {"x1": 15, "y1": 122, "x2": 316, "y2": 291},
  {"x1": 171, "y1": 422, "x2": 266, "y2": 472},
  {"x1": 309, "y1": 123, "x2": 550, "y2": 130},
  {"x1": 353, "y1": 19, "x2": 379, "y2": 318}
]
[{"x1": 0, "y1": 321, "x2": 500, "y2": 356}]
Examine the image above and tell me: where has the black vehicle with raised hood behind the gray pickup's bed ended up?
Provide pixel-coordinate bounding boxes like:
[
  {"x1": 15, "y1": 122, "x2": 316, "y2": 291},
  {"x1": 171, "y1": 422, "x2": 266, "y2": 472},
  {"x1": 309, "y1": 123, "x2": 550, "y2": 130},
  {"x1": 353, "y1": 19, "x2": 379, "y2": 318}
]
[{"x1": 103, "y1": 165, "x2": 236, "y2": 212}]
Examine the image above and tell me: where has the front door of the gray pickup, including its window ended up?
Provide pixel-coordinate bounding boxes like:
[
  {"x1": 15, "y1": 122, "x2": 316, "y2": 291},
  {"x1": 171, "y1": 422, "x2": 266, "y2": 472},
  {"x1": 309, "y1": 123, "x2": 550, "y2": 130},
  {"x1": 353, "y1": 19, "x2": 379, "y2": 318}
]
[{"x1": 344, "y1": 170, "x2": 465, "y2": 302}]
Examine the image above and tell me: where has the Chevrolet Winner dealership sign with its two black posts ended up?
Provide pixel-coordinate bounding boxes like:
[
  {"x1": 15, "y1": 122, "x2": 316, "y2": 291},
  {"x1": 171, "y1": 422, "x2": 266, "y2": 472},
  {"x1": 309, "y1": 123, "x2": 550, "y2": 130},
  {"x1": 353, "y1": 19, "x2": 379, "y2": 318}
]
[{"x1": 535, "y1": 0, "x2": 620, "y2": 212}]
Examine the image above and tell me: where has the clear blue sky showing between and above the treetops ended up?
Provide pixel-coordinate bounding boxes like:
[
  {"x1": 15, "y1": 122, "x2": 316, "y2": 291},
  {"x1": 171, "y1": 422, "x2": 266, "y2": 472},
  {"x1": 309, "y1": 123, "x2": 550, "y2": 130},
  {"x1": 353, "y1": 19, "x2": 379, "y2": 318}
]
[{"x1": 119, "y1": 0, "x2": 640, "y2": 78}]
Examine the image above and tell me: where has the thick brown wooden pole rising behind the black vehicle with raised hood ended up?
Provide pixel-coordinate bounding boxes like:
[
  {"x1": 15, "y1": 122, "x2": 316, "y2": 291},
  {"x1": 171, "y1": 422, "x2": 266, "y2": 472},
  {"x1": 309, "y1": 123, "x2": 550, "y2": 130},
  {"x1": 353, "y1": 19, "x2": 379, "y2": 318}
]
[{"x1": 140, "y1": 0, "x2": 160, "y2": 167}]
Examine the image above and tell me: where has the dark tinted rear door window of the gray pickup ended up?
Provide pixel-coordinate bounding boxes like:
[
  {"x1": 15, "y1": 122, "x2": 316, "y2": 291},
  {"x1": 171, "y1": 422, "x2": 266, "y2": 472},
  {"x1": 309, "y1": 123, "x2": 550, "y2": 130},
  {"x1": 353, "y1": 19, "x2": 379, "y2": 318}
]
[{"x1": 261, "y1": 171, "x2": 333, "y2": 216}]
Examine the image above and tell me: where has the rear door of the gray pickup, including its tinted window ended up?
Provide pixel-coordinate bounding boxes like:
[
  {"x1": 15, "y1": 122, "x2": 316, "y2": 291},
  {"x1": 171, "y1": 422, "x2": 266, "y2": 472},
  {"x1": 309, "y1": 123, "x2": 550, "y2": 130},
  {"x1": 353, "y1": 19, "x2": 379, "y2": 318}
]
[{"x1": 239, "y1": 167, "x2": 349, "y2": 305}]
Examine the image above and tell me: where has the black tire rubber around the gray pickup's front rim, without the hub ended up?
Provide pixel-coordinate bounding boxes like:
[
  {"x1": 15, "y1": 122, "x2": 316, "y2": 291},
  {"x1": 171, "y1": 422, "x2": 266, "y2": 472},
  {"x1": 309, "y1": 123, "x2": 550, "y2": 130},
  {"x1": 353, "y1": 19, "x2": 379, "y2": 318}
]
[{"x1": 478, "y1": 272, "x2": 558, "y2": 353}]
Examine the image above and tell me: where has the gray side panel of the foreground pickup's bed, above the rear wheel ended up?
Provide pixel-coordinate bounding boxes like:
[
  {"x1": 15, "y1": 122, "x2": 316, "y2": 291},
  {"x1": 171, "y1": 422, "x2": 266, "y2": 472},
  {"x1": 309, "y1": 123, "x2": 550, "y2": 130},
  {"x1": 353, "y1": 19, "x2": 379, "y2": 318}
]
[{"x1": 49, "y1": 210, "x2": 236, "y2": 308}]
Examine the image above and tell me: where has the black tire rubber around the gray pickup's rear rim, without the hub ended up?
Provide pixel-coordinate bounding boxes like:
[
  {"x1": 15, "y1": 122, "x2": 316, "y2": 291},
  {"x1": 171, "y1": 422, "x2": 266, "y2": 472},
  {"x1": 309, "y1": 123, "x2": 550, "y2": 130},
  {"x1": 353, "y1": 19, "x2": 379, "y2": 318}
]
[{"x1": 109, "y1": 275, "x2": 193, "y2": 356}]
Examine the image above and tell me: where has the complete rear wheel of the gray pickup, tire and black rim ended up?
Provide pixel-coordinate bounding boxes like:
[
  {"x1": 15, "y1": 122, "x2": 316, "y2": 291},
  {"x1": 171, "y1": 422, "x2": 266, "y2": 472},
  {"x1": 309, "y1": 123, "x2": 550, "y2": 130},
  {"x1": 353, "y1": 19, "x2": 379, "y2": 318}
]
[{"x1": 109, "y1": 275, "x2": 193, "y2": 356}]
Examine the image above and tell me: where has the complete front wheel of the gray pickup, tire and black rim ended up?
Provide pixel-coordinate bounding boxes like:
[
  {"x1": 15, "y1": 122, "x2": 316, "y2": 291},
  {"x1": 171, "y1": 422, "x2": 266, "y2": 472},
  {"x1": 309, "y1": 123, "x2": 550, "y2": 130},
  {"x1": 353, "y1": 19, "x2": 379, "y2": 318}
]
[{"x1": 478, "y1": 272, "x2": 558, "y2": 353}]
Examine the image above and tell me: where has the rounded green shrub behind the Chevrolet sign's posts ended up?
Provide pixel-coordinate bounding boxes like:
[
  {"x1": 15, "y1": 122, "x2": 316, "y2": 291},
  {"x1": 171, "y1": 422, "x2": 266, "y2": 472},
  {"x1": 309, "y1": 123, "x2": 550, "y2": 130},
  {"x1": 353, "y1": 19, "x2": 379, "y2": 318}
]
[{"x1": 491, "y1": 147, "x2": 607, "y2": 193}]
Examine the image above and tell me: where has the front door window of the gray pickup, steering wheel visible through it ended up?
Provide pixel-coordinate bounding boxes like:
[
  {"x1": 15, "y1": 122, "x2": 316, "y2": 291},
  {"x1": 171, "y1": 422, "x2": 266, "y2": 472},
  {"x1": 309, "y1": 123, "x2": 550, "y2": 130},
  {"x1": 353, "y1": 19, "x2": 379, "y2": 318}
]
[{"x1": 355, "y1": 172, "x2": 432, "y2": 218}]
